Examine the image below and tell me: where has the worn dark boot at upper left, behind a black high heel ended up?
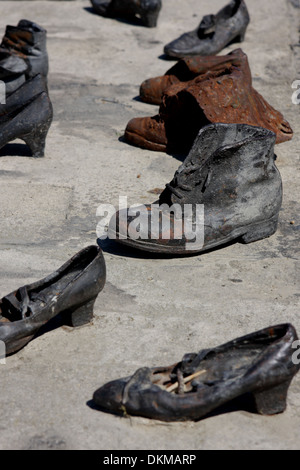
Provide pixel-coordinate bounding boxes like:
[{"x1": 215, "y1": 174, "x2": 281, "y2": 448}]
[{"x1": 0, "y1": 20, "x2": 49, "y2": 94}]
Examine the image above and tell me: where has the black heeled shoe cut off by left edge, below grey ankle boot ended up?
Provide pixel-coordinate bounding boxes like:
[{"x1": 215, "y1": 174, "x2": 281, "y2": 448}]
[{"x1": 0, "y1": 246, "x2": 106, "y2": 355}]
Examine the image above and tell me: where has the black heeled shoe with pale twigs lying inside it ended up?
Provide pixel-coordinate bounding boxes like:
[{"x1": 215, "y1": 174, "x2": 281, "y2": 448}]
[{"x1": 93, "y1": 324, "x2": 300, "y2": 421}]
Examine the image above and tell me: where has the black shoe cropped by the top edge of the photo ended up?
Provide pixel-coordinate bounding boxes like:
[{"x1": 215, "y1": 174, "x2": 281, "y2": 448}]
[{"x1": 91, "y1": 0, "x2": 162, "y2": 28}]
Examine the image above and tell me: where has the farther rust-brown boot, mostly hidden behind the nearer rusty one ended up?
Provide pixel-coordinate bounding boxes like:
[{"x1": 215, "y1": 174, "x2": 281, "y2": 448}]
[{"x1": 140, "y1": 49, "x2": 244, "y2": 105}]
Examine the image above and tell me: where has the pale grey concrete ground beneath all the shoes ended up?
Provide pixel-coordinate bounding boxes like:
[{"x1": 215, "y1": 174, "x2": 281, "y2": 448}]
[{"x1": 0, "y1": 0, "x2": 300, "y2": 450}]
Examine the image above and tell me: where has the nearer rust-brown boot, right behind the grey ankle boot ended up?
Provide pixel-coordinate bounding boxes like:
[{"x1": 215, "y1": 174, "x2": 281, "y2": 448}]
[{"x1": 124, "y1": 50, "x2": 293, "y2": 153}]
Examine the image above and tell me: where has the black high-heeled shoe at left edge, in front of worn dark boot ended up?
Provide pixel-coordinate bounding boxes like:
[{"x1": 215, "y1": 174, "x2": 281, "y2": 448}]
[{"x1": 0, "y1": 88, "x2": 53, "y2": 158}]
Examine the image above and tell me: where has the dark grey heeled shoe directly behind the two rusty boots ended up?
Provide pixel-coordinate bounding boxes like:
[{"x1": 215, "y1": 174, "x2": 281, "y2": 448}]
[{"x1": 164, "y1": 0, "x2": 250, "y2": 58}]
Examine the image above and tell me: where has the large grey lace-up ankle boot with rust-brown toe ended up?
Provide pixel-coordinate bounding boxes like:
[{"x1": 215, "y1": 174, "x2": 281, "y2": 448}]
[{"x1": 108, "y1": 123, "x2": 282, "y2": 255}]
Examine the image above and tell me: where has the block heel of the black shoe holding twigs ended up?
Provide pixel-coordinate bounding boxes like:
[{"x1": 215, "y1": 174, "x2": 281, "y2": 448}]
[{"x1": 253, "y1": 380, "x2": 291, "y2": 415}]
